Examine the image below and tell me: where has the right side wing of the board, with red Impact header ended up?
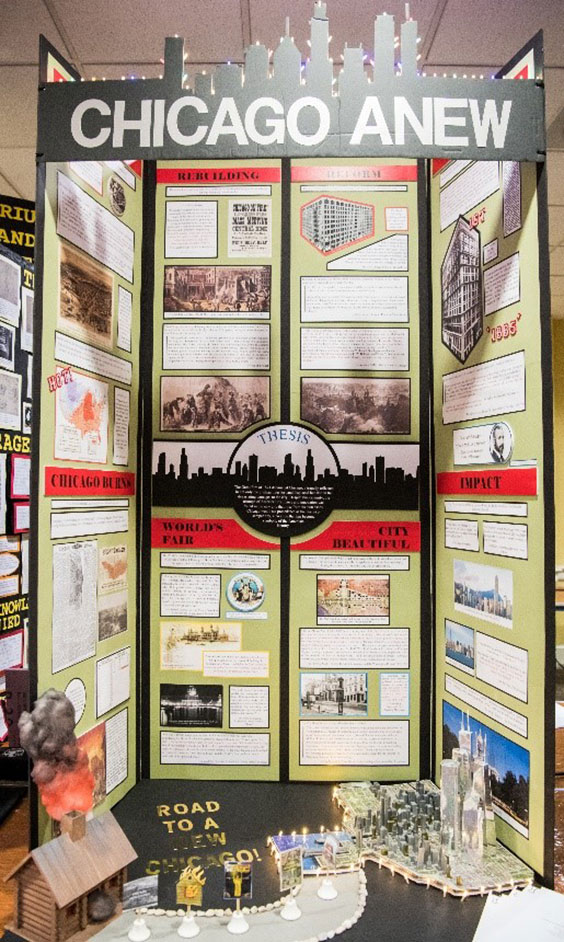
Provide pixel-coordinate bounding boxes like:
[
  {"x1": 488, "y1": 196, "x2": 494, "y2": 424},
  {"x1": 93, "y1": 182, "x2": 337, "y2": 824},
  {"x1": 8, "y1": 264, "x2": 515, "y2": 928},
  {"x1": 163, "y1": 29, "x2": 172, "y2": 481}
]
[{"x1": 431, "y1": 161, "x2": 553, "y2": 872}]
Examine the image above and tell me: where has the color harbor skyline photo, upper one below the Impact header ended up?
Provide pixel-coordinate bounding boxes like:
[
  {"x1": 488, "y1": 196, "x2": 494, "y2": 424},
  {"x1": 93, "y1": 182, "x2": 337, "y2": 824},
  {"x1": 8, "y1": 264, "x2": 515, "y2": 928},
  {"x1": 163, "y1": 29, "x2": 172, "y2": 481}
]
[{"x1": 454, "y1": 559, "x2": 513, "y2": 628}]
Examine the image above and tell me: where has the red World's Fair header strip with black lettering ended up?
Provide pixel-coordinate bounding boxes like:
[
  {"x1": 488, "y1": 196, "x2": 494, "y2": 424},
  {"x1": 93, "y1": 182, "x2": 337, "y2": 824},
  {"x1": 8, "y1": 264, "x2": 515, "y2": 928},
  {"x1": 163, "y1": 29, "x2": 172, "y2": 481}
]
[{"x1": 151, "y1": 517, "x2": 280, "y2": 550}]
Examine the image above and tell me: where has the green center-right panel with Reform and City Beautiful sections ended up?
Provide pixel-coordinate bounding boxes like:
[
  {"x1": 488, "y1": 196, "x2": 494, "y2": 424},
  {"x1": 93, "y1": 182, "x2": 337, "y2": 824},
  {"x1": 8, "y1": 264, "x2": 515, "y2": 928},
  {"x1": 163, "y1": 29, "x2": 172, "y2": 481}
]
[{"x1": 289, "y1": 159, "x2": 426, "y2": 781}]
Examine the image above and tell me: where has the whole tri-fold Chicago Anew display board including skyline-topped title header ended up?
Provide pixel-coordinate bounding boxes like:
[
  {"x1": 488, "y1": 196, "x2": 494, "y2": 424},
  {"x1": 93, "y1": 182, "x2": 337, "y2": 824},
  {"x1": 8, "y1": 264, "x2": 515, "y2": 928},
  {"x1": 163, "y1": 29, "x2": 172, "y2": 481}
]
[{"x1": 28, "y1": 3, "x2": 553, "y2": 878}]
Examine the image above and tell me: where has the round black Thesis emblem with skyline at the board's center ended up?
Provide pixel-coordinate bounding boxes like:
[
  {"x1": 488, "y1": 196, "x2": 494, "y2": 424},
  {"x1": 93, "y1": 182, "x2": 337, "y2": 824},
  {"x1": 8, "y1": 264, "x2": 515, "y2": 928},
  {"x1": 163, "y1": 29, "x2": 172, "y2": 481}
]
[{"x1": 228, "y1": 423, "x2": 339, "y2": 536}]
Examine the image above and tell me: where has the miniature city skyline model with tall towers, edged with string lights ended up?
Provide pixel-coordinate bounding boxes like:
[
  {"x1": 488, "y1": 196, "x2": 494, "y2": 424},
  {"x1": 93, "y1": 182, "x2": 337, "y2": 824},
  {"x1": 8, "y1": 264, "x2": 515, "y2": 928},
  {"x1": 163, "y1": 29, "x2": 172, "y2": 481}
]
[{"x1": 334, "y1": 719, "x2": 534, "y2": 897}]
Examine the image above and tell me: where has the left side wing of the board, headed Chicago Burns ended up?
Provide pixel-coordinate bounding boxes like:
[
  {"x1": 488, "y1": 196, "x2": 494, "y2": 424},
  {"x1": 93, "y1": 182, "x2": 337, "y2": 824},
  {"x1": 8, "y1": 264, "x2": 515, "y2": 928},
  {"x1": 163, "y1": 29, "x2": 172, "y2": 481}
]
[{"x1": 35, "y1": 161, "x2": 142, "y2": 836}]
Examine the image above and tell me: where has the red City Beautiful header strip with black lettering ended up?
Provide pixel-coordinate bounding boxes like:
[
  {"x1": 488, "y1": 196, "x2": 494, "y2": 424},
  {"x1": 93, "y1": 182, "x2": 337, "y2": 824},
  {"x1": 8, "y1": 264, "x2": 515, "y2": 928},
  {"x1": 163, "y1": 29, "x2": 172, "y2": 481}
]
[{"x1": 292, "y1": 520, "x2": 421, "y2": 553}]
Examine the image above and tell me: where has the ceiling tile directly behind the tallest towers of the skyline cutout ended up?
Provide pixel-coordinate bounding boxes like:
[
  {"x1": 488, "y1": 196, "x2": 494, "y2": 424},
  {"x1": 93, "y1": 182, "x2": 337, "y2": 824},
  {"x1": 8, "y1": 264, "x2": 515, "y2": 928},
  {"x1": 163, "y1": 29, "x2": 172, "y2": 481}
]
[{"x1": 250, "y1": 0, "x2": 435, "y2": 62}]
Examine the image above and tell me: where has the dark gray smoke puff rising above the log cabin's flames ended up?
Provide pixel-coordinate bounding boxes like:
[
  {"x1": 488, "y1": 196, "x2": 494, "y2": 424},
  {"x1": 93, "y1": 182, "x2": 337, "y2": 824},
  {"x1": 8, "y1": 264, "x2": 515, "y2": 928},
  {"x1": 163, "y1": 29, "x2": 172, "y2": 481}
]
[{"x1": 18, "y1": 689, "x2": 78, "y2": 785}]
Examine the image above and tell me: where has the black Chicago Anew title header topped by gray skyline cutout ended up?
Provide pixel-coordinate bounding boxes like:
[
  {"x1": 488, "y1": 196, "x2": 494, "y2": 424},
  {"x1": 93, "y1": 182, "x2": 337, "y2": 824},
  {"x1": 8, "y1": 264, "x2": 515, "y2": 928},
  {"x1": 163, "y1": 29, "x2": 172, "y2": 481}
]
[{"x1": 38, "y1": 2, "x2": 544, "y2": 160}]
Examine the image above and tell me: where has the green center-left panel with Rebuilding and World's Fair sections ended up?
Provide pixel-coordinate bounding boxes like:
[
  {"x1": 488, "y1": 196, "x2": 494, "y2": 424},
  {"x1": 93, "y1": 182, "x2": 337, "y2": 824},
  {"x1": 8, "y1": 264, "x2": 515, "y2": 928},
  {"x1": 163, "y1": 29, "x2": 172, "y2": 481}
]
[{"x1": 149, "y1": 160, "x2": 281, "y2": 780}]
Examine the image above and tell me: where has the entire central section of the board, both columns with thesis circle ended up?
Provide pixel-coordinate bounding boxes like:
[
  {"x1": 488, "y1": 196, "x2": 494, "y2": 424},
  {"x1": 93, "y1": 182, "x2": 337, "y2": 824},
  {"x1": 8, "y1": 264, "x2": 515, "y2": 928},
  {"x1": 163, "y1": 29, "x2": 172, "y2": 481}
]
[{"x1": 147, "y1": 160, "x2": 427, "y2": 780}]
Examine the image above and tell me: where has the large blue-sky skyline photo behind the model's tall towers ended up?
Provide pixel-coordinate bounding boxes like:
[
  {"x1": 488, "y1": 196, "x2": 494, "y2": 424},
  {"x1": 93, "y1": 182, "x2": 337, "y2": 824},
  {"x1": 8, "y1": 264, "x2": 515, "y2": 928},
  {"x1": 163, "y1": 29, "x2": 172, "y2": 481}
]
[{"x1": 443, "y1": 700, "x2": 530, "y2": 837}]
